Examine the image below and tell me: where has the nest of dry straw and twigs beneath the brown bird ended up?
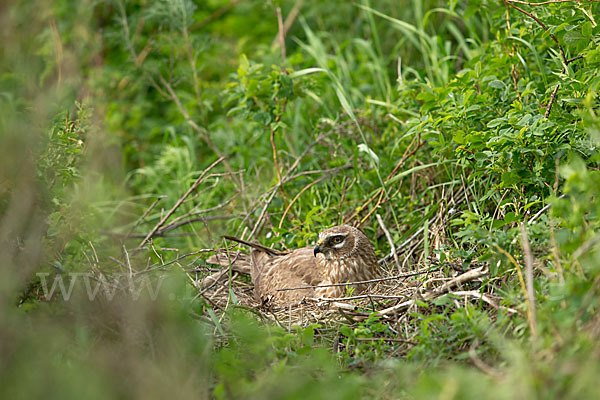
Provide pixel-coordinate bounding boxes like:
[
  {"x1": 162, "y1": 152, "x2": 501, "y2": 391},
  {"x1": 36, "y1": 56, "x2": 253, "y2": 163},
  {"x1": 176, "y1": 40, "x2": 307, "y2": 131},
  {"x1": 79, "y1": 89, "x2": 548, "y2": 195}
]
[{"x1": 193, "y1": 260, "x2": 506, "y2": 330}]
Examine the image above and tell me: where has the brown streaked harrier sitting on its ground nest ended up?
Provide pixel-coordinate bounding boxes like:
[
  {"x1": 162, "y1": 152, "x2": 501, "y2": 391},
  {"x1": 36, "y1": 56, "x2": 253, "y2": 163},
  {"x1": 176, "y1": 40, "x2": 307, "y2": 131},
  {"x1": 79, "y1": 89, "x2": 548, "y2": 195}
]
[{"x1": 207, "y1": 225, "x2": 379, "y2": 306}]
